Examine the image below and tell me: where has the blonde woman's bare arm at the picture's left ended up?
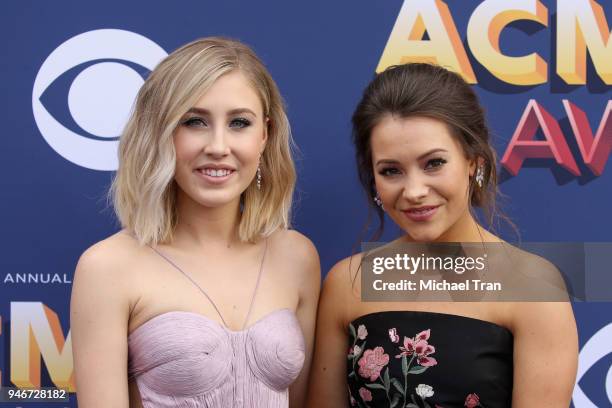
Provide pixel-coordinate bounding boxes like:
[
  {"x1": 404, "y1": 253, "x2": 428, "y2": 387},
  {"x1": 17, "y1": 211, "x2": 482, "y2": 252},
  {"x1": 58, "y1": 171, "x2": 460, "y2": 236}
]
[{"x1": 70, "y1": 244, "x2": 130, "y2": 408}]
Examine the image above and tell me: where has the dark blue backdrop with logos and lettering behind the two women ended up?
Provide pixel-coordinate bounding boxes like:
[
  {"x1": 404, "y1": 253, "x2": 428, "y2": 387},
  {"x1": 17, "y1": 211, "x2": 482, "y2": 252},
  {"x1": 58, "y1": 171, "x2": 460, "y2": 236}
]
[{"x1": 0, "y1": 0, "x2": 612, "y2": 408}]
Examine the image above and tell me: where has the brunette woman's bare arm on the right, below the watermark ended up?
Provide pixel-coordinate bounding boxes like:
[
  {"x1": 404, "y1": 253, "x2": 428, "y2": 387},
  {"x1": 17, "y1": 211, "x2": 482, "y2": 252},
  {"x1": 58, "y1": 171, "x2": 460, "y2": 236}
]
[{"x1": 512, "y1": 302, "x2": 578, "y2": 408}]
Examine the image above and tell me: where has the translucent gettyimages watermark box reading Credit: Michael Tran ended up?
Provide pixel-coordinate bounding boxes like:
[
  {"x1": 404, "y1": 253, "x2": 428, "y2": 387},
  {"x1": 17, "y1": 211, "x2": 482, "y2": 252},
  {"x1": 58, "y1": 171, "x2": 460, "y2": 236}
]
[{"x1": 359, "y1": 240, "x2": 612, "y2": 302}]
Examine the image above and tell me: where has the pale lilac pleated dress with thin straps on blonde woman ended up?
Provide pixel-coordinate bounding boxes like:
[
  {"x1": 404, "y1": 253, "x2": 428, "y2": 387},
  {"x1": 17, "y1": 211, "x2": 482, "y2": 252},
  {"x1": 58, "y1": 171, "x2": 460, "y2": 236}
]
[{"x1": 128, "y1": 241, "x2": 304, "y2": 408}]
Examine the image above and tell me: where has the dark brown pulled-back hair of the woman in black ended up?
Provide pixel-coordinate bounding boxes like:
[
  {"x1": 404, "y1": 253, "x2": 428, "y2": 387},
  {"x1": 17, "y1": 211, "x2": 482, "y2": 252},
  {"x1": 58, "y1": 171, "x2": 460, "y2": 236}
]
[{"x1": 353, "y1": 63, "x2": 515, "y2": 240}]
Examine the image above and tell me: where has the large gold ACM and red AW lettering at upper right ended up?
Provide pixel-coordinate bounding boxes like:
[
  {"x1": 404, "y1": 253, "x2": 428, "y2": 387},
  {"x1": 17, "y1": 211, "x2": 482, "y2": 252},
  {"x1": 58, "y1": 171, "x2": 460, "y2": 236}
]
[{"x1": 377, "y1": 0, "x2": 612, "y2": 176}]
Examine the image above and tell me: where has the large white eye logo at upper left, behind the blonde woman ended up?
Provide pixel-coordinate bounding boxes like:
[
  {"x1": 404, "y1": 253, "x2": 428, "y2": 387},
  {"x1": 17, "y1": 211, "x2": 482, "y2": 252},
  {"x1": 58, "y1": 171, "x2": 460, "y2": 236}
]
[{"x1": 32, "y1": 29, "x2": 167, "y2": 171}]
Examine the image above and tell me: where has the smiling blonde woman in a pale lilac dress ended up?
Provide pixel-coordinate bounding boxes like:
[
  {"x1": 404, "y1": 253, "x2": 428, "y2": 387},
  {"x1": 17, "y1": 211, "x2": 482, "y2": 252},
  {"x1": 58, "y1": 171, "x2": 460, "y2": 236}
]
[{"x1": 70, "y1": 38, "x2": 320, "y2": 408}]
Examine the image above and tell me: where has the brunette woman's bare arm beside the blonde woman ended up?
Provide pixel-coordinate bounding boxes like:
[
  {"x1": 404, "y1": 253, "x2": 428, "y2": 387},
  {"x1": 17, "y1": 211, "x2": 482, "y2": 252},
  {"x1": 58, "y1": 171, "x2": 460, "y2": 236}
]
[{"x1": 307, "y1": 259, "x2": 358, "y2": 408}]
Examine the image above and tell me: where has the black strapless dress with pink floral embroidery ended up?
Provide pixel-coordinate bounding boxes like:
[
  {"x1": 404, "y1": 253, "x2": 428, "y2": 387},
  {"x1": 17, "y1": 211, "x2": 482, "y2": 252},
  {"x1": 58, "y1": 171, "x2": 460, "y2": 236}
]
[{"x1": 347, "y1": 311, "x2": 513, "y2": 408}]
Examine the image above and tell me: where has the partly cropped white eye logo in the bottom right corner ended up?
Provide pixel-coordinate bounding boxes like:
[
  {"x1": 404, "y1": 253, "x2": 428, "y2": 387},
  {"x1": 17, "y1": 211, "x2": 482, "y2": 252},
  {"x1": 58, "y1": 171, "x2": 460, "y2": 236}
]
[{"x1": 572, "y1": 323, "x2": 612, "y2": 408}]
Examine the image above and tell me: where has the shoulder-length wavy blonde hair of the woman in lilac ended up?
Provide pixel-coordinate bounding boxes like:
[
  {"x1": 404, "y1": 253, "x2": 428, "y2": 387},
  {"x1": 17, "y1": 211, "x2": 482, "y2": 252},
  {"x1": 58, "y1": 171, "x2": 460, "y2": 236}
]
[{"x1": 110, "y1": 37, "x2": 296, "y2": 244}]
